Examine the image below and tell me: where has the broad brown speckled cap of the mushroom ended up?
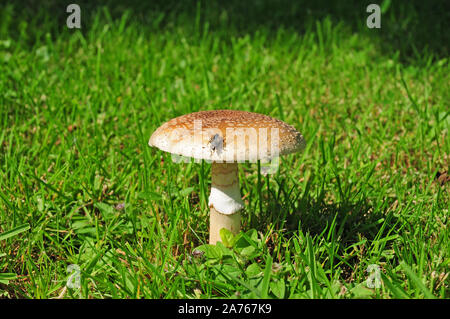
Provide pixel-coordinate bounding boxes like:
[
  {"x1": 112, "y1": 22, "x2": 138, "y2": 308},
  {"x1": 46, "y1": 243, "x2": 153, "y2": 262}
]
[{"x1": 148, "y1": 110, "x2": 305, "y2": 163}]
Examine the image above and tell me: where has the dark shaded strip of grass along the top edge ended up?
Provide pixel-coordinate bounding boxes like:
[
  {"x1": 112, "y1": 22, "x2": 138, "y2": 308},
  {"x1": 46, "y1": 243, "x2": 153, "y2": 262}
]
[{"x1": 0, "y1": 0, "x2": 450, "y2": 63}]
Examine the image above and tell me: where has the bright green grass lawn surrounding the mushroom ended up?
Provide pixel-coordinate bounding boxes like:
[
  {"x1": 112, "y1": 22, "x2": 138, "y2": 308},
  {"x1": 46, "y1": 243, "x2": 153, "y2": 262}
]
[{"x1": 0, "y1": 1, "x2": 450, "y2": 298}]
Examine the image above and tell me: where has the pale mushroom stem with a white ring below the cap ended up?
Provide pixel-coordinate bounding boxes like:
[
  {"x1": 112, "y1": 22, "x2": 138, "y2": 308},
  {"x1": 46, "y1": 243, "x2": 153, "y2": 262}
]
[{"x1": 209, "y1": 163, "x2": 244, "y2": 245}]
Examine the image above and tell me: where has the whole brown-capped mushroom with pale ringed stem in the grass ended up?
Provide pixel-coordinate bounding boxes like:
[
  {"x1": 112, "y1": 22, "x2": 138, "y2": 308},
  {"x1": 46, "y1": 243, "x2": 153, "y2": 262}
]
[{"x1": 149, "y1": 110, "x2": 305, "y2": 244}]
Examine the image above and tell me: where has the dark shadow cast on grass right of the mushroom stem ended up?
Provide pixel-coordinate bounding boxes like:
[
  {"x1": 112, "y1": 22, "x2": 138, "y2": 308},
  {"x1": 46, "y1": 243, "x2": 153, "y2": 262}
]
[{"x1": 255, "y1": 176, "x2": 397, "y2": 246}]
